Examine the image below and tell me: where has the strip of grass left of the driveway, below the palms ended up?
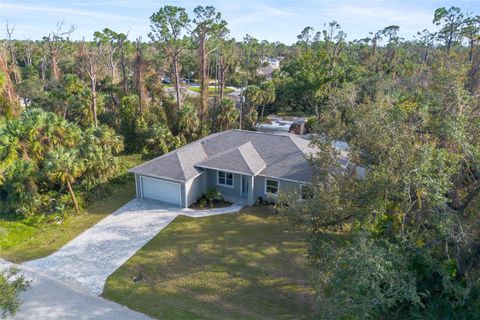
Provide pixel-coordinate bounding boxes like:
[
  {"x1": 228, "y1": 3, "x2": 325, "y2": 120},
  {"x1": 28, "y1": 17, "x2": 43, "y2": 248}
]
[{"x1": 0, "y1": 155, "x2": 140, "y2": 263}]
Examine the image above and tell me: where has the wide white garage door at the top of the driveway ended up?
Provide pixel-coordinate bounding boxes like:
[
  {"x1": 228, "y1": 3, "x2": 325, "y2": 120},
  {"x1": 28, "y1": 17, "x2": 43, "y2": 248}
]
[{"x1": 141, "y1": 177, "x2": 181, "y2": 206}]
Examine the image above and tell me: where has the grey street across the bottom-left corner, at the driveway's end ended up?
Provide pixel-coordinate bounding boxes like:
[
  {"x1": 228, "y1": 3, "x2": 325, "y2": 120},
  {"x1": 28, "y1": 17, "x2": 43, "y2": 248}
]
[{"x1": 0, "y1": 259, "x2": 151, "y2": 320}]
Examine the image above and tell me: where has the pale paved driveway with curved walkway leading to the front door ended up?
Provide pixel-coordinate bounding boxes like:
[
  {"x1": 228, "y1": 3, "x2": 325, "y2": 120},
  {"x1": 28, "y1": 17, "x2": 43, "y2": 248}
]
[{"x1": 24, "y1": 199, "x2": 242, "y2": 295}]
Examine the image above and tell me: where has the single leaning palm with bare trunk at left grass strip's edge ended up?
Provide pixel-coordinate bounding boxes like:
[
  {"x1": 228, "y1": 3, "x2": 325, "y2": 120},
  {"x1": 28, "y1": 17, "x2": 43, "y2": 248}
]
[{"x1": 45, "y1": 146, "x2": 84, "y2": 213}]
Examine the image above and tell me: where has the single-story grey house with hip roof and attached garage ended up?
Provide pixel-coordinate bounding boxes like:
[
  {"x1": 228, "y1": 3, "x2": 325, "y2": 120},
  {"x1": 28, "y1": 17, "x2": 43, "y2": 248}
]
[{"x1": 129, "y1": 130, "x2": 346, "y2": 207}]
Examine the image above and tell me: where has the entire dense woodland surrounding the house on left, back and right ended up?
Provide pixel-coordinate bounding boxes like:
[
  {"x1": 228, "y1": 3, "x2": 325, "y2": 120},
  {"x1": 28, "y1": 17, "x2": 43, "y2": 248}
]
[{"x1": 0, "y1": 6, "x2": 480, "y2": 319}]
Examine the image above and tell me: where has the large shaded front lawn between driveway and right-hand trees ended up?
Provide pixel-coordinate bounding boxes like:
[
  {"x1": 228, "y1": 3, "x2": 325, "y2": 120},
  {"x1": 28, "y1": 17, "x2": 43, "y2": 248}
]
[{"x1": 103, "y1": 207, "x2": 315, "y2": 319}]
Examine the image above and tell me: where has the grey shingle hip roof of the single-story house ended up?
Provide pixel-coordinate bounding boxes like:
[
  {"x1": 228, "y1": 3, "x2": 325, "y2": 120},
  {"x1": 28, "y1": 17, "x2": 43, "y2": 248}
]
[{"x1": 129, "y1": 130, "x2": 315, "y2": 182}]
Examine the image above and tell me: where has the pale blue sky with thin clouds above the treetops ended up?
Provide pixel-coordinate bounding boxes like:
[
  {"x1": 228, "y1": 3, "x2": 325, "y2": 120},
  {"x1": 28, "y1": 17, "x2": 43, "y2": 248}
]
[{"x1": 0, "y1": 0, "x2": 480, "y2": 44}]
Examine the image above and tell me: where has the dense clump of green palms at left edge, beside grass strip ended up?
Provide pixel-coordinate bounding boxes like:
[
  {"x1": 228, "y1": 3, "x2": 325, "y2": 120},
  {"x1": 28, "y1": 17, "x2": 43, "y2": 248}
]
[{"x1": 0, "y1": 108, "x2": 123, "y2": 217}]
